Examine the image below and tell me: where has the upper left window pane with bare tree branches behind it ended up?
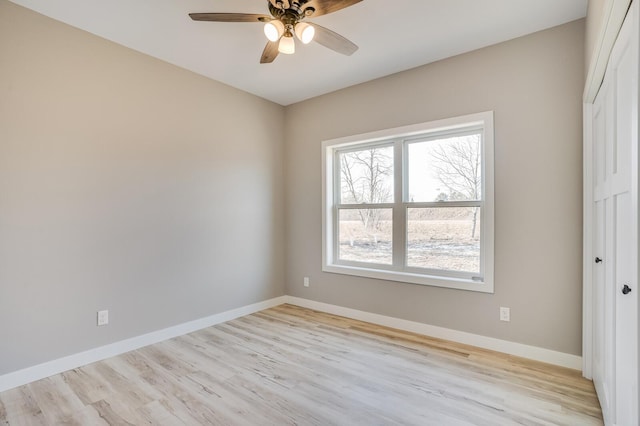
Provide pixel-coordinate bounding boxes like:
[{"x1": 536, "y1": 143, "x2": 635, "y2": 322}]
[{"x1": 338, "y1": 146, "x2": 393, "y2": 204}]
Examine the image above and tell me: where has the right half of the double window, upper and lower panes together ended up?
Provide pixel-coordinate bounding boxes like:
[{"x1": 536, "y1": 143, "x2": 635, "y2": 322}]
[{"x1": 406, "y1": 133, "x2": 482, "y2": 273}]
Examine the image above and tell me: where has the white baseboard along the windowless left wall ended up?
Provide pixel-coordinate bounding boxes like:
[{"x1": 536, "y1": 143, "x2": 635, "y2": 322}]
[{"x1": 0, "y1": 296, "x2": 287, "y2": 392}]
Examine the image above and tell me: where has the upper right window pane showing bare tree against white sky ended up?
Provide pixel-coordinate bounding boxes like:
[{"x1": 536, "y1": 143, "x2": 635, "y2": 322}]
[{"x1": 407, "y1": 133, "x2": 482, "y2": 202}]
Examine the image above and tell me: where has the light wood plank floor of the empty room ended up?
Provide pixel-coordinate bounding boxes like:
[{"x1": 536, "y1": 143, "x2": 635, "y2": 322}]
[{"x1": 0, "y1": 305, "x2": 602, "y2": 426}]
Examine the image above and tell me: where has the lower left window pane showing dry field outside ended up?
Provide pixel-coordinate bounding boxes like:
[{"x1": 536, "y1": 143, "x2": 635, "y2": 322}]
[{"x1": 338, "y1": 209, "x2": 393, "y2": 265}]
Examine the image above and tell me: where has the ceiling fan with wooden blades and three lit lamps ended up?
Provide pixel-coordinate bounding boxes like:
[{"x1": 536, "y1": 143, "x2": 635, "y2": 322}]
[{"x1": 189, "y1": 0, "x2": 362, "y2": 64}]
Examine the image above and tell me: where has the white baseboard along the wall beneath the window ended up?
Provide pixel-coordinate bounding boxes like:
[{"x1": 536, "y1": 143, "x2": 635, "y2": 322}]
[{"x1": 285, "y1": 296, "x2": 582, "y2": 370}]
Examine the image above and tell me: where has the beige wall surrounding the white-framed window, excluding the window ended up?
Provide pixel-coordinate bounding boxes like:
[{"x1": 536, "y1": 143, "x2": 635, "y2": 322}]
[{"x1": 285, "y1": 20, "x2": 584, "y2": 354}]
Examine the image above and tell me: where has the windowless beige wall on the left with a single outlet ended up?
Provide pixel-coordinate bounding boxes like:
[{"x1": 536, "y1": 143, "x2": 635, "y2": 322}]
[{"x1": 0, "y1": 0, "x2": 284, "y2": 375}]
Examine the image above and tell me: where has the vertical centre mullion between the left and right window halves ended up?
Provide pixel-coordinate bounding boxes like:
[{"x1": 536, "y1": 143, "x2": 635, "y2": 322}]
[{"x1": 393, "y1": 140, "x2": 407, "y2": 270}]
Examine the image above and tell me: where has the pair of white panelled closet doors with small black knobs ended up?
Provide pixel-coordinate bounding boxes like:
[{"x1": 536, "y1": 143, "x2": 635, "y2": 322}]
[{"x1": 592, "y1": 1, "x2": 640, "y2": 426}]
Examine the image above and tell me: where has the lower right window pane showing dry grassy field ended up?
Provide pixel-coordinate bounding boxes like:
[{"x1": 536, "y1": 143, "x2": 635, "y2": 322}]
[{"x1": 407, "y1": 207, "x2": 480, "y2": 274}]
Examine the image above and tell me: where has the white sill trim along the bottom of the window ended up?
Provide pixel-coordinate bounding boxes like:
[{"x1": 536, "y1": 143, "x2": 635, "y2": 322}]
[{"x1": 322, "y1": 264, "x2": 493, "y2": 293}]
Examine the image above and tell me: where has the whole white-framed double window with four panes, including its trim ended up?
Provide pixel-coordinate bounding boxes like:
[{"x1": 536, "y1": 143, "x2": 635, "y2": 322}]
[{"x1": 322, "y1": 112, "x2": 493, "y2": 292}]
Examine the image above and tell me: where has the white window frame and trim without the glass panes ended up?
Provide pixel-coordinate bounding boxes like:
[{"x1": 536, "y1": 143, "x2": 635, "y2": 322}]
[{"x1": 322, "y1": 111, "x2": 494, "y2": 293}]
